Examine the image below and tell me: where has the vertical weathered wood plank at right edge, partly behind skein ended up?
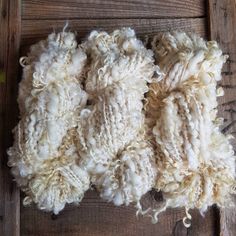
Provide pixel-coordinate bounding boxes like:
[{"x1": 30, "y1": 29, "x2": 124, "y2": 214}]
[{"x1": 209, "y1": 0, "x2": 236, "y2": 236}]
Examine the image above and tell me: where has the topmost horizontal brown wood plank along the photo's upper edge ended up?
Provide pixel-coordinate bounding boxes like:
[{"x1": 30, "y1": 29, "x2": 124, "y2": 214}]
[{"x1": 22, "y1": 0, "x2": 205, "y2": 19}]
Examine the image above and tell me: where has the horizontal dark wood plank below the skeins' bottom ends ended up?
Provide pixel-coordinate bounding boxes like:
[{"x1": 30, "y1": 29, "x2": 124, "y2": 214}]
[{"x1": 21, "y1": 191, "x2": 218, "y2": 236}]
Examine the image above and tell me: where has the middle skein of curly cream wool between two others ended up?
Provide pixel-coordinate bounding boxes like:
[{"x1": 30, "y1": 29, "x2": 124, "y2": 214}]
[{"x1": 78, "y1": 28, "x2": 156, "y2": 208}]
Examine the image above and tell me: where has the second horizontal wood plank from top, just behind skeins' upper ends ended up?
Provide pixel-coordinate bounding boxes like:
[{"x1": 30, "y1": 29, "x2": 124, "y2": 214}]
[{"x1": 22, "y1": 18, "x2": 206, "y2": 45}]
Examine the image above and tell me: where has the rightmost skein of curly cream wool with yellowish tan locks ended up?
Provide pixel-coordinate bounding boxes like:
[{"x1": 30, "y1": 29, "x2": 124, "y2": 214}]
[{"x1": 145, "y1": 32, "x2": 235, "y2": 226}]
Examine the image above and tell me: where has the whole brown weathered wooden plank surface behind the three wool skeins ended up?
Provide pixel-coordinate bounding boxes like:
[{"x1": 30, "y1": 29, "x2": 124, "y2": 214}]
[{"x1": 0, "y1": 0, "x2": 236, "y2": 236}]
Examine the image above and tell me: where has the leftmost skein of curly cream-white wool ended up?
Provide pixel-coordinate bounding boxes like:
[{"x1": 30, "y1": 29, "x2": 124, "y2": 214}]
[{"x1": 8, "y1": 32, "x2": 90, "y2": 214}]
